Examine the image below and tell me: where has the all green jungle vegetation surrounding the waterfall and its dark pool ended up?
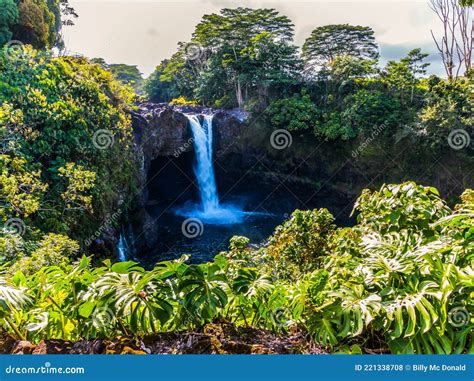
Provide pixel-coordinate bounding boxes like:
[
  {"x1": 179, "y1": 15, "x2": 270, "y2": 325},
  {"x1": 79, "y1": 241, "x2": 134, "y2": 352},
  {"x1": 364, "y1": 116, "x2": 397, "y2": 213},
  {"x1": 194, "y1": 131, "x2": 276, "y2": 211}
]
[{"x1": 0, "y1": 0, "x2": 474, "y2": 353}]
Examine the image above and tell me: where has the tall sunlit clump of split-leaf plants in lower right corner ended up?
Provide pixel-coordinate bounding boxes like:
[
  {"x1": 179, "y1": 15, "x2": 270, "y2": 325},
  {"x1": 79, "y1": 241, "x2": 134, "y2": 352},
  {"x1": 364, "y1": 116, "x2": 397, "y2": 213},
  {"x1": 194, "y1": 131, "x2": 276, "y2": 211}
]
[{"x1": 308, "y1": 183, "x2": 474, "y2": 353}]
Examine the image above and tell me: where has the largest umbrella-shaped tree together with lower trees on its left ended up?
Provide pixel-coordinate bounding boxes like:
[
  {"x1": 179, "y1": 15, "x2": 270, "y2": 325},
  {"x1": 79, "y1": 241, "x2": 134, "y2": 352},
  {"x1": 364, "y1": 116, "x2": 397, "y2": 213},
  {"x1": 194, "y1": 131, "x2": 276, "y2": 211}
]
[{"x1": 147, "y1": 8, "x2": 299, "y2": 108}]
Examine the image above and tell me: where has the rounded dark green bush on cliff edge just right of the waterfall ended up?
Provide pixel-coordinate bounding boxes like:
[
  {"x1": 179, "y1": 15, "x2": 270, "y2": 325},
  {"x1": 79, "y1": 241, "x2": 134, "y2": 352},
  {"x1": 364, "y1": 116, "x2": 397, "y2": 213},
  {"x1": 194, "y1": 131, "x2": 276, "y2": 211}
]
[{"x1": 265, "y1": 92, "x2": 319, "y2": 131}]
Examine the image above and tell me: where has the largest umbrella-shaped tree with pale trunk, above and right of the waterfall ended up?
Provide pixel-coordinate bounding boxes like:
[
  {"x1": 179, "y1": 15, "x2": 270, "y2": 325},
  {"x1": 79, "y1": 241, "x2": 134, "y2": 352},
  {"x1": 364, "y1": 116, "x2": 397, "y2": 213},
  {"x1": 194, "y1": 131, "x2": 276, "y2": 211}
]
[{"x1": 193, "y1": 8, "x2": 298, "y2": 108}]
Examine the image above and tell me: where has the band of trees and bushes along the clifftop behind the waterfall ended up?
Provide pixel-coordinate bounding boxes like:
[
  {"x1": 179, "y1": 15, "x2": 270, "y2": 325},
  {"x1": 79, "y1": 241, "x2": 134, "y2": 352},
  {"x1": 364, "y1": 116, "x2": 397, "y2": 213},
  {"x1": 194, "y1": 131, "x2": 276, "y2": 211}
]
[{"x1": 144, "y1": 8, "x2": 473, "y2": 148}]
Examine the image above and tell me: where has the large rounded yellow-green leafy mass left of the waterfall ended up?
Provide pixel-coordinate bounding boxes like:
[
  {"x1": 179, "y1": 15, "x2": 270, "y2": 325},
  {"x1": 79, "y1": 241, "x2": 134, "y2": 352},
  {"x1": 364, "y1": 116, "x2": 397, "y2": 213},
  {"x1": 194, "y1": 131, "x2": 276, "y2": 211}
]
[{"x1": 0, "y1": 49, "x2": 137, "y2": 246}]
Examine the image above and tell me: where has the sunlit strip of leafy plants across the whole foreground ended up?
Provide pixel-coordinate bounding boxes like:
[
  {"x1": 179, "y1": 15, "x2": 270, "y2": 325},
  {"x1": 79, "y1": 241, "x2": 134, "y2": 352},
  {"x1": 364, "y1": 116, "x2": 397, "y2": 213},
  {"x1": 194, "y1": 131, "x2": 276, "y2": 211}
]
[{"x1": 0, "y1": 183, "x2": 474, "y2": 353}]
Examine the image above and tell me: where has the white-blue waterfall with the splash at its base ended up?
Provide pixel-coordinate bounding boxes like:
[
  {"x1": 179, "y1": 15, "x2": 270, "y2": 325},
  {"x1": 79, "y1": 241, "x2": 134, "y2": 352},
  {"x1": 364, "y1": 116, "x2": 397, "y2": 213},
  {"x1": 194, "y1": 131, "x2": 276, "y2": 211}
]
[{"x1": 177, "y1": 115, "x2": 245, "y2": 225}]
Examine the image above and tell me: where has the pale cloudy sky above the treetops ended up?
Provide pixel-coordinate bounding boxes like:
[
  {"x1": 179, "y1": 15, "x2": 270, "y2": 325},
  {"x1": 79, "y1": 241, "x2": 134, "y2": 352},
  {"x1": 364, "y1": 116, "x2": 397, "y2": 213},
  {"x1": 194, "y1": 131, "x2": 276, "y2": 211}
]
[{"x1": 63, "y1": 0, "x2": 443, "y2": 76}]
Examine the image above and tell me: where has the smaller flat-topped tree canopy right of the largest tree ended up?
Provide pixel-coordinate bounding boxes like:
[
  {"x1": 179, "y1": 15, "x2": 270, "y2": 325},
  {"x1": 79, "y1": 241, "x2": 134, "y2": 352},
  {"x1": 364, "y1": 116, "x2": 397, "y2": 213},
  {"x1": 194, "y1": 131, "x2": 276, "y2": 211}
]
[{"x1": 303, "y1": 24, "x2": 379, "y2": 67}]
